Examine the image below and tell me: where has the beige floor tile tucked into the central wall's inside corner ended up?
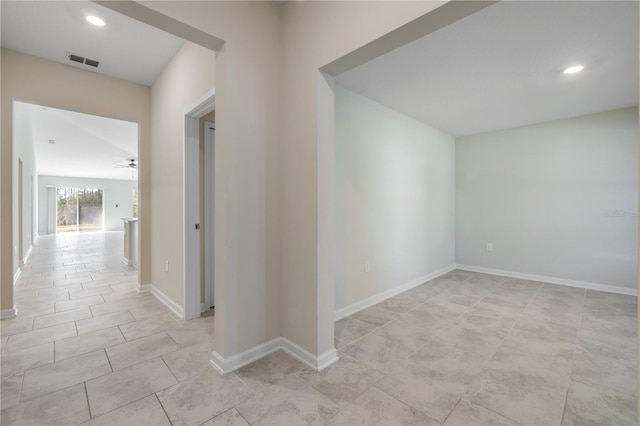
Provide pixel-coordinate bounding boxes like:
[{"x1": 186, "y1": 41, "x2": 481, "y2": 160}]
[{"x1": 235, "y1": 350, "x2": 305, "y2": 389}]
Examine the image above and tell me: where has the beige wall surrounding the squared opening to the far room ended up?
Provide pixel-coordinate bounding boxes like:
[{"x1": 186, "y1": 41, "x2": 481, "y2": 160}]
[{"x1": 0, "y1": 49, "x2": 150, "y2": 309}]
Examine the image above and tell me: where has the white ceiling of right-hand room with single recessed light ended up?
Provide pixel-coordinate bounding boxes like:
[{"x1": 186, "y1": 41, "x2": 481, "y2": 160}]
[{"x1": 336, "y1": 1, "x2": 638, "y2": 136}]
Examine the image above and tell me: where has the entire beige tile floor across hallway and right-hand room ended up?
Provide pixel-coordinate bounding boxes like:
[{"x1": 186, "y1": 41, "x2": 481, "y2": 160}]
[{"x1": 0, "y1": 233, "x2": 638, "y2": 426}]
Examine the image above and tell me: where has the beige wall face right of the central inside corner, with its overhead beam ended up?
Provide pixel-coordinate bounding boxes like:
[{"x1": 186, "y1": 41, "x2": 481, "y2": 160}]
[{"x1": 281, "y1": 1, "x2": 442, "y2": 355}]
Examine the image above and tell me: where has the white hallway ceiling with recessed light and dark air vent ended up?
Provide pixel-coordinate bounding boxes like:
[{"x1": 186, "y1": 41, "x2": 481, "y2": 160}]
[{"x1": 0, "y1": 0, "x2": 184, "y2": 86}]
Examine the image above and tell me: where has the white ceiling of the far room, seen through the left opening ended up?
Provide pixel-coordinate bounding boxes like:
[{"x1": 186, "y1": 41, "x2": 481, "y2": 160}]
[{"x1": 14, "y1": 102, "x2": 138, "y2": 180}]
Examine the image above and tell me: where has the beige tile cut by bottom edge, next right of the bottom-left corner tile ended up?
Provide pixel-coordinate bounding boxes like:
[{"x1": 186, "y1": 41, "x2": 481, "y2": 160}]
[{"x1": 83, "y1": 395, "x2": 171, "y2": 426}]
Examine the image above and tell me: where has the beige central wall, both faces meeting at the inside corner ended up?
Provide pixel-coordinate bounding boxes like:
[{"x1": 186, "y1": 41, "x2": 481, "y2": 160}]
[{"x1": 120, "y1": 1, "x2": 458, "y2": 357}]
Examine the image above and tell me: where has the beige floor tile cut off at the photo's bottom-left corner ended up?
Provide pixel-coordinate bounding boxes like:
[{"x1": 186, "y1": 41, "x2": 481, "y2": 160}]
[{"x1": 0, "y1": 383, "x2": 89, "y2": 426}]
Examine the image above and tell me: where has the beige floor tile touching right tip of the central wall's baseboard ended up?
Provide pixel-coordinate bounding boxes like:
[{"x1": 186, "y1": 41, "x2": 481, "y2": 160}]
[{"x1": 298, "y1": 357, "x2": 384, "y2": 406}]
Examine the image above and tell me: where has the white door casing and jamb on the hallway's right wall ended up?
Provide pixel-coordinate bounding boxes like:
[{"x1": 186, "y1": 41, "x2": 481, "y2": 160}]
[{"x1": 182, "y1": 89, "x2": 215, "y2": 319}]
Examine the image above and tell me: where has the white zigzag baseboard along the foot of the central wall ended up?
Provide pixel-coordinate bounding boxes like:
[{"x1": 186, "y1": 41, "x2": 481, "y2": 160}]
[{"x1": 209, "y1": 337, "x2": 338, "y2": 374}]
